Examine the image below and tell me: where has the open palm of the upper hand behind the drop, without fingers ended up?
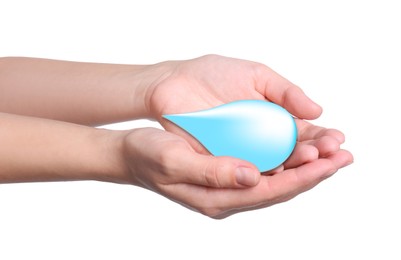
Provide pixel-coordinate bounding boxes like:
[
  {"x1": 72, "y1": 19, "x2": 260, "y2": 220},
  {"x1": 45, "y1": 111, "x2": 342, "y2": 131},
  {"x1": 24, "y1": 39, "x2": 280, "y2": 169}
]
[{"x1": 151, "y1": 57, "x2": 264, "y2": 123}]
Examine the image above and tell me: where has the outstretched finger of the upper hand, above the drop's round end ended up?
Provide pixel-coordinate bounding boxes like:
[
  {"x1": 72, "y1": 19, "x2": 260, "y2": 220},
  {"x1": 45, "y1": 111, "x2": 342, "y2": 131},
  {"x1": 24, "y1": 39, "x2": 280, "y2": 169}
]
[{"x1": 256, "y1": 65, "x2": 322, "y2": 119}]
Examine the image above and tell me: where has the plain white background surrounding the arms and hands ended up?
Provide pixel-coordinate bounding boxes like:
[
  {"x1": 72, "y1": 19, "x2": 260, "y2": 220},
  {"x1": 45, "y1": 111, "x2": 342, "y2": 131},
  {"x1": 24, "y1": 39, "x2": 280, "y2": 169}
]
[{"x1": 0, "y1": 0, "x2": 401, "y2": 259}]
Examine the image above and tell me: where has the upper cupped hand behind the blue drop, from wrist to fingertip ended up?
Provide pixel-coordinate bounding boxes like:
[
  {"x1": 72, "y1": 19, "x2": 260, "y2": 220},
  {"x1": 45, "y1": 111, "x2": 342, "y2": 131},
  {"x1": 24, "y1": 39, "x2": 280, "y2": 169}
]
[{"x1": 145, "y1": 55, "x2": 322, "y2": 153}]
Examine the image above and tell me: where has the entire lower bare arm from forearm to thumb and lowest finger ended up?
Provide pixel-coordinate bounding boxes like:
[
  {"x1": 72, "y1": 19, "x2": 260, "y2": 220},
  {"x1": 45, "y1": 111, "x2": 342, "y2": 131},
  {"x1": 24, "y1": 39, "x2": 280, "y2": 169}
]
[{"x1": 0, "y1": 113, "x2": 352, "y2": 218}]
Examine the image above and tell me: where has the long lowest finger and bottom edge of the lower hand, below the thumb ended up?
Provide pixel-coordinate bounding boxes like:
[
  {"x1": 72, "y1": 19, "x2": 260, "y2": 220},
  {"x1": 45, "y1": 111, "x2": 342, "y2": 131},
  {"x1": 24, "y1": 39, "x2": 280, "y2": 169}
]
[{"x1": 167, "y1": 150, "x2": 353, "y2": 218}]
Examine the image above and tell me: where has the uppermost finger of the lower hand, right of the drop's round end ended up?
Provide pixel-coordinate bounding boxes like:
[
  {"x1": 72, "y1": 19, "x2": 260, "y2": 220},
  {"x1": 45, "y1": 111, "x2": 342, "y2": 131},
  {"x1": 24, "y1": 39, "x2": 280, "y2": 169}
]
[{"x1": 295, "y1": 119, "x2": 345, "y2": 144}]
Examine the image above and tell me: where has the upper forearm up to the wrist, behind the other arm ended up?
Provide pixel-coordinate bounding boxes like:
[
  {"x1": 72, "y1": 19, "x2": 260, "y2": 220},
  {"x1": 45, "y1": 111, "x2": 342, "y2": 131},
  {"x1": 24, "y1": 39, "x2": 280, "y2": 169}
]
[{"x1": 0, "y1": 58, "x2": 148, "y2": 125}]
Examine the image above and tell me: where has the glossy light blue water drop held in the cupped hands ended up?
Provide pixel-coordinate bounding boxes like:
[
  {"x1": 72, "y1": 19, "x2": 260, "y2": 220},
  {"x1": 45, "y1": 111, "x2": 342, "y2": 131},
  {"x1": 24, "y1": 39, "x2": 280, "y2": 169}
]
[{"x1": 163, "y1": 100, "x2": 297, "y2": 172}]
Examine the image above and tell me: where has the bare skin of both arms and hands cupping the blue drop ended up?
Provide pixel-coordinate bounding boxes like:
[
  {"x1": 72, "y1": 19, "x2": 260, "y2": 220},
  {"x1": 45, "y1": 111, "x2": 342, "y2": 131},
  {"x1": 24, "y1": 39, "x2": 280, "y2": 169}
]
[{"x1": 0, "y1": 55, "x2": 353, "y2": 218}]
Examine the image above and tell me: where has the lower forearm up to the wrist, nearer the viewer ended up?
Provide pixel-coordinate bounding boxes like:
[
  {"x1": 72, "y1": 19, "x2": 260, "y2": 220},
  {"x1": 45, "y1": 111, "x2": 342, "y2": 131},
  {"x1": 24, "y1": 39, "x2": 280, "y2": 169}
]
[{"x1": 0, "y1": 113, "x2": 125, "y2": 183}]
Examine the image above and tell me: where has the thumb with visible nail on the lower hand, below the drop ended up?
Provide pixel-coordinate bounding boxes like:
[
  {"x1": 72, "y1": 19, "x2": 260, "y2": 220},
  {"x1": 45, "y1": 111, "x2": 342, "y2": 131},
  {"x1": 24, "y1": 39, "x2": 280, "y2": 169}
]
[{"x1": 183, "y1": 153, "x2": 260, "y2": 188}]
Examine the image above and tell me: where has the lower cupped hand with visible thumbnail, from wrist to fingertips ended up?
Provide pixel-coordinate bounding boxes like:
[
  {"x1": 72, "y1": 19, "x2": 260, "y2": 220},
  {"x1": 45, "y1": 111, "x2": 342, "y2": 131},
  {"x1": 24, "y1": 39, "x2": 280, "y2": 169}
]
[{"x1": 122, "y1": 125, "x2": 352, "y2": 218}]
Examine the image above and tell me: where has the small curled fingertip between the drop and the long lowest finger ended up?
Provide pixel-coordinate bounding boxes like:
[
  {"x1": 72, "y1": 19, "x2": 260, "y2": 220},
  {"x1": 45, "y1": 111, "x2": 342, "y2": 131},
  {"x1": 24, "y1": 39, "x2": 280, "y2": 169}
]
[{"x1": 284, "y1": 142, "x2": 319, "y2": 169}]
